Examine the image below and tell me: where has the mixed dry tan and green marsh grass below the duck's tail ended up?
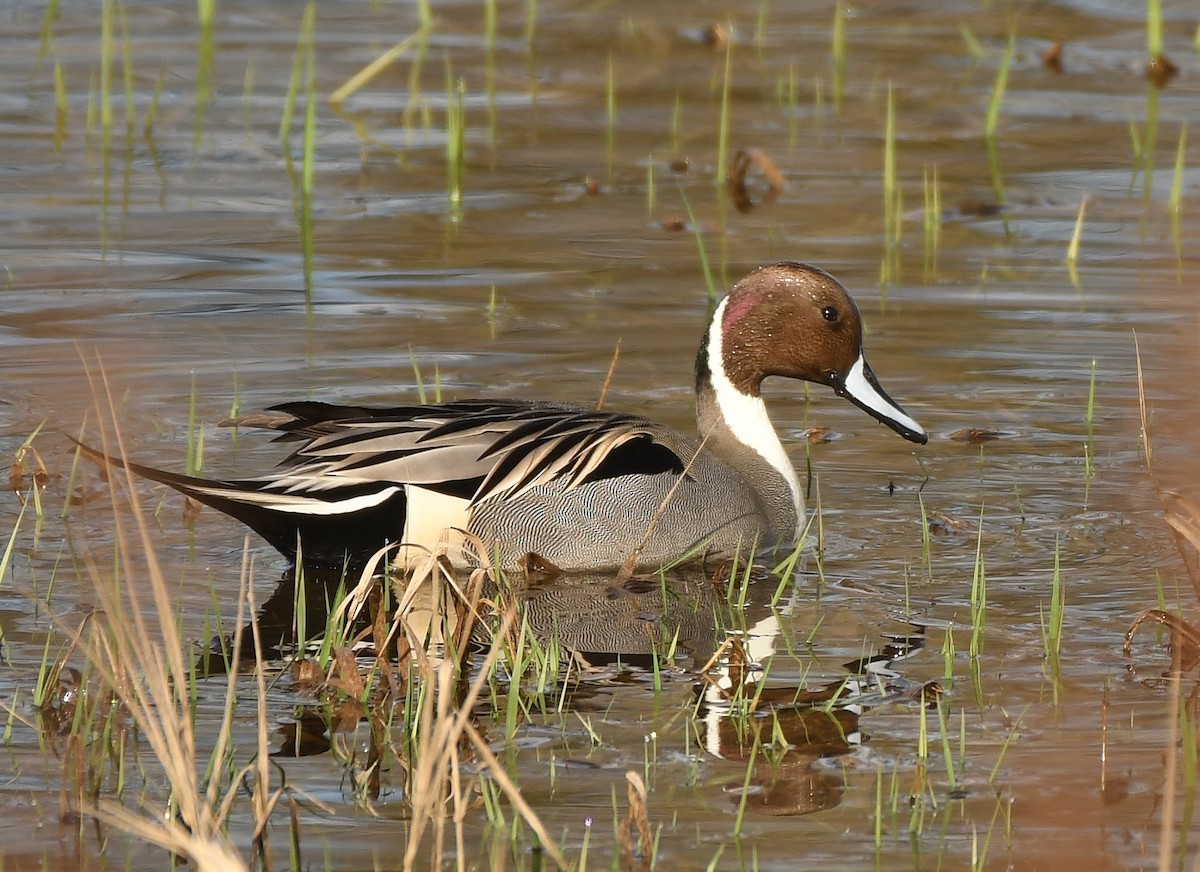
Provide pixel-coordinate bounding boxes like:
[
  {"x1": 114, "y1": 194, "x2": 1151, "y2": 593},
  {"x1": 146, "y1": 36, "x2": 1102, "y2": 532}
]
[{"x1": 28, "y1": 359, "x2": 580, "y2": 870}]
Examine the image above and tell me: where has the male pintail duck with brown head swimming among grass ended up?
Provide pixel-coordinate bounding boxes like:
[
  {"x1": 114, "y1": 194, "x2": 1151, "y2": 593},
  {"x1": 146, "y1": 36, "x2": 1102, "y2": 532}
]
[{"x1": 87, "y1": 263, "x2": 928, "y2": 570}]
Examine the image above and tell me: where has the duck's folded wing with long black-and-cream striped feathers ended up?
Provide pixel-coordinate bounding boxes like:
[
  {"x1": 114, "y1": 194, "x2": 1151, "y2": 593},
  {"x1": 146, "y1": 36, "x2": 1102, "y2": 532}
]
[{"x1": 242, "y1": 401, "x2": 695, "y2": 505}]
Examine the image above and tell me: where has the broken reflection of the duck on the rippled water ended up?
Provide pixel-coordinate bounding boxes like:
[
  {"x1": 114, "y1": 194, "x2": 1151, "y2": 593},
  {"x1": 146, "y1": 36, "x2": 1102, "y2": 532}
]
[{"x1": 226, "y1": 563, "x2": 924, "y2": 814}]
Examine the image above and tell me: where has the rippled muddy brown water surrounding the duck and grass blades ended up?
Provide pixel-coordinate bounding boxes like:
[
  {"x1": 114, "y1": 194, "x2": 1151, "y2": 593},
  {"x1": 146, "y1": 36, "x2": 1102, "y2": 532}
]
[{"x1": 0, "y1": 0, "x2": 1200, "y2": 870}]
